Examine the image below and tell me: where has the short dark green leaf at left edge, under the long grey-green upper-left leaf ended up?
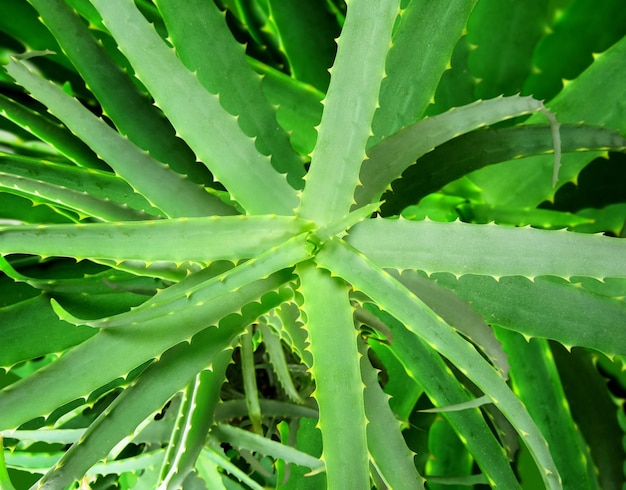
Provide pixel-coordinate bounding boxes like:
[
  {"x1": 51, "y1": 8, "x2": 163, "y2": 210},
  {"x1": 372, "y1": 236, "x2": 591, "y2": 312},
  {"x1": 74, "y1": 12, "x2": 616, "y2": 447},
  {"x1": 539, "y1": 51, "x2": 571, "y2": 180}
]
[{"x1": 0, "y1": 94, "x2": 108, "y2": 170}]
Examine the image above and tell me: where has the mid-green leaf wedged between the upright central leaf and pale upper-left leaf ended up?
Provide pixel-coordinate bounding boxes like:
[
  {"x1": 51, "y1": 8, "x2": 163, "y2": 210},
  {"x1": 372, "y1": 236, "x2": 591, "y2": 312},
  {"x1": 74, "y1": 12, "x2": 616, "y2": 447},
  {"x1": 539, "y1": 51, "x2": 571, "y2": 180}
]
[{"x1": 157, "y1": 0, "x2": 304, "y2": 189}]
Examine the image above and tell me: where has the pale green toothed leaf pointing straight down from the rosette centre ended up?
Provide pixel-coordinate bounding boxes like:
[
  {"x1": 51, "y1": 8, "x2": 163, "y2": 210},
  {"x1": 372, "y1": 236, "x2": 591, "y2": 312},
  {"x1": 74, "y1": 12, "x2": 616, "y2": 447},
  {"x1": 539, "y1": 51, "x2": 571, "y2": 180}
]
[{"x1": 297, "y1": 262, "x2": 369, "y2": 488}]
